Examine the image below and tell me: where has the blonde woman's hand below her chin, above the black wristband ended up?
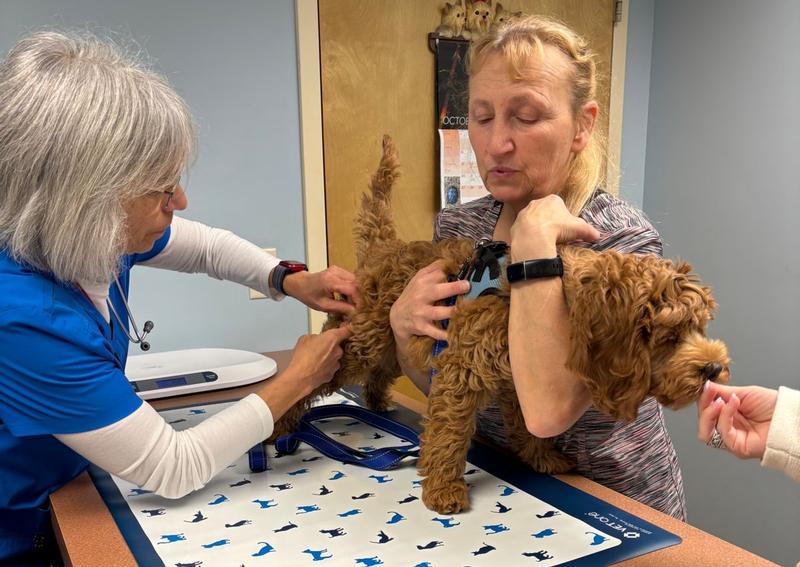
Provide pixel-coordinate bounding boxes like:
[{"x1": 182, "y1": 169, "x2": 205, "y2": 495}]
[{"x1": 510, "y1": 195, "x2": 600, "y2": 262}]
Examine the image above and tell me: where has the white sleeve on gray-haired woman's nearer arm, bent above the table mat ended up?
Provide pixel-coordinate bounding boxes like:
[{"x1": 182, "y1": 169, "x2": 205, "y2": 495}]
[{"x1": 55, "y1": 394, "x2": 274, "y2": 498}]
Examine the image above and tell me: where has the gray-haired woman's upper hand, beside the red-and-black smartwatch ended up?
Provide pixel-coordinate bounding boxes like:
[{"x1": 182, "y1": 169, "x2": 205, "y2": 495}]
[{"x1": 283, "y1": 266, "x2": 361, "y2": 316}]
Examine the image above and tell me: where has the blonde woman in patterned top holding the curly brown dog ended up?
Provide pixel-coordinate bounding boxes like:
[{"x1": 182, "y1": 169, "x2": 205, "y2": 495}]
[{"x1": 390, "y1": 16, "x2": 686, "y2": 519}]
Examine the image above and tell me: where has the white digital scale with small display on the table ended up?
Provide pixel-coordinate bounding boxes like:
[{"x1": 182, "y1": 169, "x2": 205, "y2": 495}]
[{"x1": 125, "y1": 348, "x2": 278, "y2": 400}]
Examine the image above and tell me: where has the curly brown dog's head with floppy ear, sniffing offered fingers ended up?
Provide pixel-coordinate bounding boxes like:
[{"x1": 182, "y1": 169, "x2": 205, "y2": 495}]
[{"x1": 562, "y1": 248, "x2": 730, "y2": 421}]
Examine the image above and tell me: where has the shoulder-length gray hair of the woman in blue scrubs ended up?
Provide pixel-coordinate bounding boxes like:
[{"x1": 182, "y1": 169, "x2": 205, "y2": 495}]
[{"x1": 0, "y1": 32, "x2": 196, "y2": 282}]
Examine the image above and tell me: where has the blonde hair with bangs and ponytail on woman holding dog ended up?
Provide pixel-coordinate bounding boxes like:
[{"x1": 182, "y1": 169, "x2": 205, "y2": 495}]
[{"x1": 468, "y1": 16, "x2": 606, "y2": 214}]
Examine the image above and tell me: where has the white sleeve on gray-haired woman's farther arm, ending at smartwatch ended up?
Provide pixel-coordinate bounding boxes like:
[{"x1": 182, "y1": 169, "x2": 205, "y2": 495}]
[{"x1": 140, "y1": 216, "x2": 284, "y2": 299}]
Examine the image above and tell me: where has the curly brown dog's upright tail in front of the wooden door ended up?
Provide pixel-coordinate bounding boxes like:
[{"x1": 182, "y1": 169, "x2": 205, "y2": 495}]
[{"x1": 353, "y1": 135, "x2": 400, "y2": 267}]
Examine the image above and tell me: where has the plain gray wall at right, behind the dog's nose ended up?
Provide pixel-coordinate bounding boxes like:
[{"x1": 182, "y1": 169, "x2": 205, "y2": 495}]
[{"x1": 623, "y1": 0, "x2": 800, "y2": 565}]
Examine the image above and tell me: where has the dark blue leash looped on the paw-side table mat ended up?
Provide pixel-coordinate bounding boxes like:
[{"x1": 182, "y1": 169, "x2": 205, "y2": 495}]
[{"x1": 262, "y1": 404, "x2": 419, "y2": 471}]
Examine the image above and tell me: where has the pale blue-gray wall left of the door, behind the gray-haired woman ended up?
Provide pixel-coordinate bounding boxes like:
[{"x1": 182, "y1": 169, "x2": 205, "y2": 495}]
[{"x1": 0, "y1": 0, "x2": 308, "y2": 354}]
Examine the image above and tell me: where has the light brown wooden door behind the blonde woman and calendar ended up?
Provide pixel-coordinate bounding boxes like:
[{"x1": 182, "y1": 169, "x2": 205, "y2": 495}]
[{"x1": 318, "y1": 0, "x2": 614, "y2": 400}]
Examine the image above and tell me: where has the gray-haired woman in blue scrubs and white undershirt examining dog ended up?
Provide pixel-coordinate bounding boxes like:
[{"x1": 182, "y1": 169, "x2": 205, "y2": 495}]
[{"x1": 0, "y1": 32, "x2": 357, "y2": 564}]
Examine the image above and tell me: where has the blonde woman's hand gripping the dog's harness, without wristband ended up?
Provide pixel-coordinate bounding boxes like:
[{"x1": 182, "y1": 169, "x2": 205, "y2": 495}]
[{"x1": 389, "y1": 260, "x2": 469, "y2": 344}]
